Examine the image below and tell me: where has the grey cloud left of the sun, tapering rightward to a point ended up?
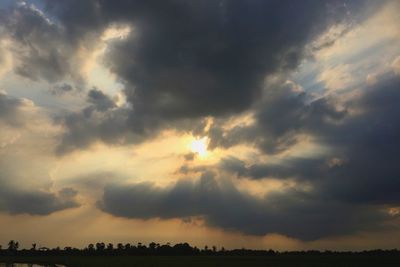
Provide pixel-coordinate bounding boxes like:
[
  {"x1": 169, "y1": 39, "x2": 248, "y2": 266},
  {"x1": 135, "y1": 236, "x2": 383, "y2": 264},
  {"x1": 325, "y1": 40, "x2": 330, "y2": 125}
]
[{"x1": 56, "y1": 89, "x2": 205, "y2": 155}]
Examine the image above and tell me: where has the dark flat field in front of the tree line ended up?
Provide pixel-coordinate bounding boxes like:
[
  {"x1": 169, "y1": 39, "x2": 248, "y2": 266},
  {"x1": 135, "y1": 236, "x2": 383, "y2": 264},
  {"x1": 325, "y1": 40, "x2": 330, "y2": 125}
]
[{"x1": 0, "y1": 255, "x2": 400, "y2": 267}]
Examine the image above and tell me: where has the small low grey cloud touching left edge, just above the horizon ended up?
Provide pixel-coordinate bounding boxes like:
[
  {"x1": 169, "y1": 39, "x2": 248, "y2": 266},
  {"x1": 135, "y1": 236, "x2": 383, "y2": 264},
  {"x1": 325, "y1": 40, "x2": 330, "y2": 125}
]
[{"x1": 0, "y1": 186, "x2": 79, "y2": 215}]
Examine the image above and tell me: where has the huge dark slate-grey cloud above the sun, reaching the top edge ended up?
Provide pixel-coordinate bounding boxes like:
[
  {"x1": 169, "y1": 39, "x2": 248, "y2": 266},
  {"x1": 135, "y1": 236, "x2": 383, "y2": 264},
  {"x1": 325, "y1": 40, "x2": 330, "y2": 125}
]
[{"x1": 104, "y1": 1, "x2": 346, "y2": 119}]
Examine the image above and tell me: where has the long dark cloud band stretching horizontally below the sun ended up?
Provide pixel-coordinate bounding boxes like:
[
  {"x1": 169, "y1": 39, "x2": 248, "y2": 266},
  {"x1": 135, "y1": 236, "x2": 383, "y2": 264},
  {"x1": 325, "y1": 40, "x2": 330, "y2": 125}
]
[{"x1": 98, "y1": 172, "x2": 388, "y2": 240}]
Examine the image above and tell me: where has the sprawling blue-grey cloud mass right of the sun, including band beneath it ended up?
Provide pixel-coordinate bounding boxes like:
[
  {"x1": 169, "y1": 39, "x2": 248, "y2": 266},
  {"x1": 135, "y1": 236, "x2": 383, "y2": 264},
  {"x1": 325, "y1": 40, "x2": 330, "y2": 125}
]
[{"x1": 134, "y1": 74, "x2": 400, "y2": 240}]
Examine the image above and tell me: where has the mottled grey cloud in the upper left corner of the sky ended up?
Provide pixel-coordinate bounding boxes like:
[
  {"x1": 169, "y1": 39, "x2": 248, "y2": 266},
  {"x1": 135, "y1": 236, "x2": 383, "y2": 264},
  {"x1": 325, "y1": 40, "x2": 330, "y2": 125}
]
[{"x1": 3, "y1": 4, "x2": 73, "y2": 82}]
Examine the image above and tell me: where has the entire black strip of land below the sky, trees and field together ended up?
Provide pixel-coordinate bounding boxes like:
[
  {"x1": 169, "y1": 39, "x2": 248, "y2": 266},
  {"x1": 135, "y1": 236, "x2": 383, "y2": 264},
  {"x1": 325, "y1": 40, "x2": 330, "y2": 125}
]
[{"x1": 0, "y1": 240, "x2": 400, "y2": 267}]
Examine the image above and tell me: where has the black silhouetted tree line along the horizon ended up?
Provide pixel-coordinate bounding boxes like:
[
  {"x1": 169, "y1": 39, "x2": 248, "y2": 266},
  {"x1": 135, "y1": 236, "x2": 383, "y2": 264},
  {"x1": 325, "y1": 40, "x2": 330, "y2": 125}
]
[{"x1": 0, "y1": 240, "x2": 400, "y2": 257}]
